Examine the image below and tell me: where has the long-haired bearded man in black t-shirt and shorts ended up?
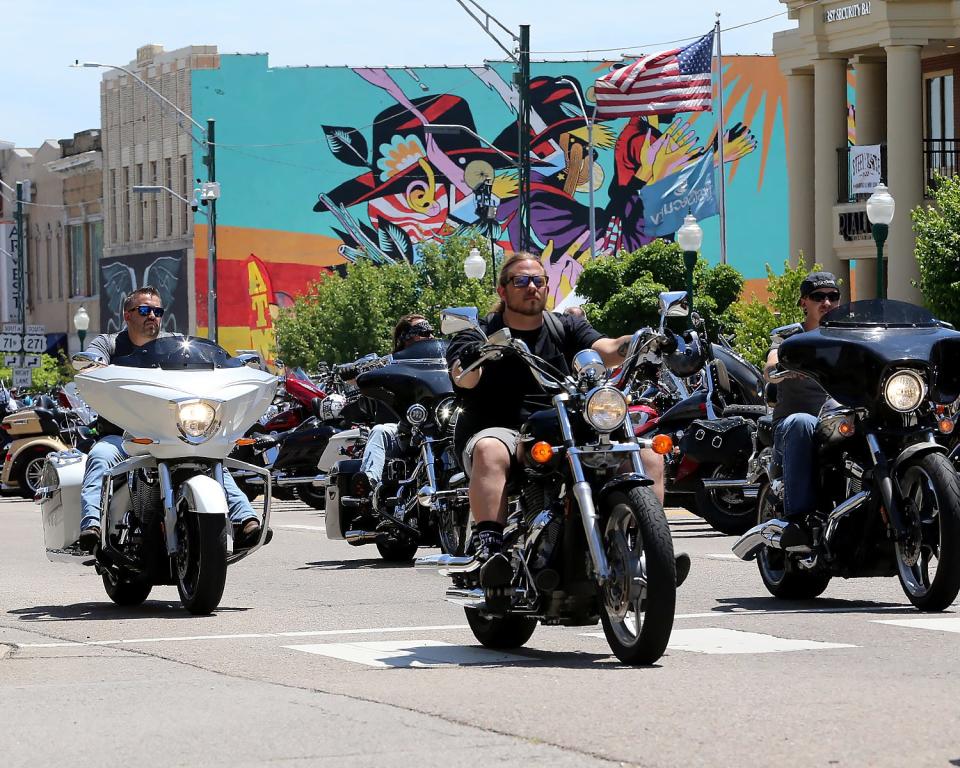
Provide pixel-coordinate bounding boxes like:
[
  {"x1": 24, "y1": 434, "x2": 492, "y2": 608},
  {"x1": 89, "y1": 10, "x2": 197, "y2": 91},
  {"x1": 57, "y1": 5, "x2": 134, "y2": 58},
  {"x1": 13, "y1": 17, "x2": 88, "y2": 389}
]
[{"x1": 447, "y1": 253, "x2": 689, "y2": 582}]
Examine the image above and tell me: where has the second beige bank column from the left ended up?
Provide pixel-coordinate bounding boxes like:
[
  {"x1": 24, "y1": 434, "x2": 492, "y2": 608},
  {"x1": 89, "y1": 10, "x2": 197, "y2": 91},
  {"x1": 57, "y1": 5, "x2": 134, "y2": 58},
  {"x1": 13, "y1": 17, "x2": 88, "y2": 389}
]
[{"x1": 813, "y1": 59, "x2": 850, "y2": 285}]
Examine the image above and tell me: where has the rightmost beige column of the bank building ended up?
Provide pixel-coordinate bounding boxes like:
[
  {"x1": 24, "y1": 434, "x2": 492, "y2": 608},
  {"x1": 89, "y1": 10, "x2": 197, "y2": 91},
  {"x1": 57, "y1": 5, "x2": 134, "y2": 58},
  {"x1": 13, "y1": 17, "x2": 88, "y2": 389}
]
[{"x1": 884, "y1": 45, "x2": 923, "y2": 304}]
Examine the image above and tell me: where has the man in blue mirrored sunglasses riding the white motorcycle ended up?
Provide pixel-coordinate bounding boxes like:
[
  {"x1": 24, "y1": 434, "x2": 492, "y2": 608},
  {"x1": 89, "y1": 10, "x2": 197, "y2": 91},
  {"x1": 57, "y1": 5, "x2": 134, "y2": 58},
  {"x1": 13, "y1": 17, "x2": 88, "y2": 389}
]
[{"x1": 80, "y1": 285, "x2": 260, "y2": 552}]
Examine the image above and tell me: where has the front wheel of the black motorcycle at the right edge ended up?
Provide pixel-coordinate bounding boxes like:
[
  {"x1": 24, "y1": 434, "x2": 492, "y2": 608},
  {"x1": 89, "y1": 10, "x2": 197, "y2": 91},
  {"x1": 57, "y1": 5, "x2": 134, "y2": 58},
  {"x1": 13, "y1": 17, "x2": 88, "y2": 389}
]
[{"x1": 896, "y1": 453, "x2": 960, "y2": 612}]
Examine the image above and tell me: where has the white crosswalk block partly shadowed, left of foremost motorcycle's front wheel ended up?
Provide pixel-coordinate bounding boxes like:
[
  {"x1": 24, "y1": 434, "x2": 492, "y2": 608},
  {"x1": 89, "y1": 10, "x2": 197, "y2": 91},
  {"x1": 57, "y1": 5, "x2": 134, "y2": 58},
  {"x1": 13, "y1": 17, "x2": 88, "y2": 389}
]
[{"x1": 283, "y1": 640, "x2": 525, "y2": 668}]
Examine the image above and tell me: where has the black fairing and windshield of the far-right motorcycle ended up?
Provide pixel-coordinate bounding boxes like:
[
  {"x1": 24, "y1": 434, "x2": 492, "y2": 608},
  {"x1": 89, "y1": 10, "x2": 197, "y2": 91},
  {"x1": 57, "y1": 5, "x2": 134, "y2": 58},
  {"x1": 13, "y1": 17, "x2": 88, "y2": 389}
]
[{"x1": 779, "y1": 299, "x2": 960, "y2": 408}]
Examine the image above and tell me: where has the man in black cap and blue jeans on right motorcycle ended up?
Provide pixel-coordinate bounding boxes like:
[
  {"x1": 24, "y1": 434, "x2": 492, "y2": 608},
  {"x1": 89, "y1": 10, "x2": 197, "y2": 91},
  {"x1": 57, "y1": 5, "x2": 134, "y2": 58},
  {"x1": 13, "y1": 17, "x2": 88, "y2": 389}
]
[{"x1": 763, "y1": 272, "x2": 840, "y2": 546}]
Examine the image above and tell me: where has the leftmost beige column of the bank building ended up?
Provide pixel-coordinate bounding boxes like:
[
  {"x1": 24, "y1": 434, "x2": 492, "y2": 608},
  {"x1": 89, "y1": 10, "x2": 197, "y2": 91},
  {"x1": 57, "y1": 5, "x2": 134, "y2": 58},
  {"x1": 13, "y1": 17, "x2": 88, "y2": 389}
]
[{"x1": 787, "y1": 72, "x2": 816, "y2": 266}]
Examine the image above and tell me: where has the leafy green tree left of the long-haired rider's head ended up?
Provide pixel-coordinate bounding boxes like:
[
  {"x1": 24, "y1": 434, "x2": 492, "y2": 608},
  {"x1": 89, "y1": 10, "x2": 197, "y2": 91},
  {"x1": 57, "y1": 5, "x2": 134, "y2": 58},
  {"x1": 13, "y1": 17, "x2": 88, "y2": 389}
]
[{"x1": 276, "y1": 236, "x2": 496, "y2": 370}]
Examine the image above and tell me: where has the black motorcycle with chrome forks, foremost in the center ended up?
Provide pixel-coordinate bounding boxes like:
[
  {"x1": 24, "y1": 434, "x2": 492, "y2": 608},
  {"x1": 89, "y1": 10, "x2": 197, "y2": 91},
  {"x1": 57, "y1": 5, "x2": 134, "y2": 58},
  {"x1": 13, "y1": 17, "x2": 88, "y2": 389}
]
[{"x1": 417, "y1": 307, "x2": 676, "y2": 664}]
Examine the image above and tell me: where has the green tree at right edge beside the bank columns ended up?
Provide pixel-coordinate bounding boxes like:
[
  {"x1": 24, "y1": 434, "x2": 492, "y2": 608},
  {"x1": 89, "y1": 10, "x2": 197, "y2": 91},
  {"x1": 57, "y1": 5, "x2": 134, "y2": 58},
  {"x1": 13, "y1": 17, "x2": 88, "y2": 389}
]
[{"x1": 910, "y1": 176, "x2": 960, "y2": 325}]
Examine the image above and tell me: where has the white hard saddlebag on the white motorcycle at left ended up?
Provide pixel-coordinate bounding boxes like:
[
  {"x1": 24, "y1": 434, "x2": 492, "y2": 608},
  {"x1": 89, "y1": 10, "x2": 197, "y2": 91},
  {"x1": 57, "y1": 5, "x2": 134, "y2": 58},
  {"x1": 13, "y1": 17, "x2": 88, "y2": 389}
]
[{"x1": 38, "y1": 450, "x2": 90, "y2": 562}]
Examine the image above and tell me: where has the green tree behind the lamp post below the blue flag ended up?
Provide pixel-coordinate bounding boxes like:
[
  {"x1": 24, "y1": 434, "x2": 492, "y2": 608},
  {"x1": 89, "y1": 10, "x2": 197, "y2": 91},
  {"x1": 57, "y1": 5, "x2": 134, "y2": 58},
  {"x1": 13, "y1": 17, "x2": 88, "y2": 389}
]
[{"x1": 577, "y1": 240, "x2": 743, "y2": 336}]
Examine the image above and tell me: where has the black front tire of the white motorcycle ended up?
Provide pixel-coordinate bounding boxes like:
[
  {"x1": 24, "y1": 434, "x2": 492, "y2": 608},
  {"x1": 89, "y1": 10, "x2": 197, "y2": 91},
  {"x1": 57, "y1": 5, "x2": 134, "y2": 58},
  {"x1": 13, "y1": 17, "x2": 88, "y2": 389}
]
[{"x1": 176, "y1": 510, "x2": 227, "y2": 615}]
